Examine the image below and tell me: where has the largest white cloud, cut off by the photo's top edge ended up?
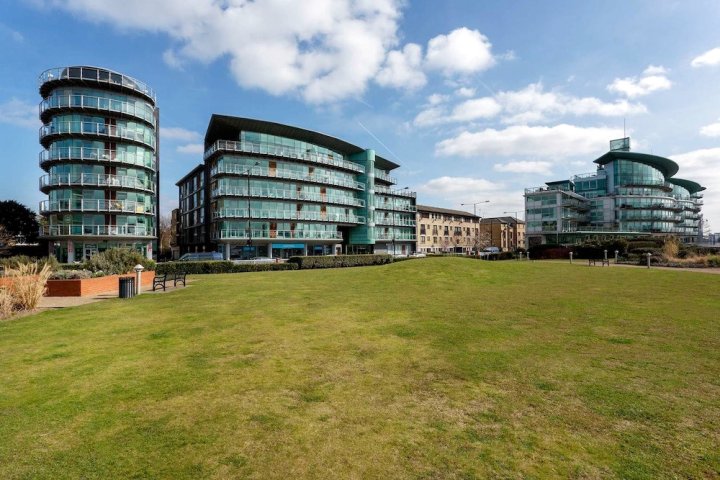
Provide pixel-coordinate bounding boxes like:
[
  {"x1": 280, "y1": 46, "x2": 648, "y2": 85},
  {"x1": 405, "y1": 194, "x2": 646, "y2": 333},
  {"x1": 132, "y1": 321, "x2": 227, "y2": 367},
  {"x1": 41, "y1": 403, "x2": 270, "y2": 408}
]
[{"x1": 39, "y1": 0, "x2": 404, "y2": 103}]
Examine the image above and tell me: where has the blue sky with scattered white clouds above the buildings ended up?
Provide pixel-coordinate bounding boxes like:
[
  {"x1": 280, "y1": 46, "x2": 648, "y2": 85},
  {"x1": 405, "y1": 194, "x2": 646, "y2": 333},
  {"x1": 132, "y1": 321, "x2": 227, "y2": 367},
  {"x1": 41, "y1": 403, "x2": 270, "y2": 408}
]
[{"x1": 0, "y1": 0, "x2": 720, "y2": 231}]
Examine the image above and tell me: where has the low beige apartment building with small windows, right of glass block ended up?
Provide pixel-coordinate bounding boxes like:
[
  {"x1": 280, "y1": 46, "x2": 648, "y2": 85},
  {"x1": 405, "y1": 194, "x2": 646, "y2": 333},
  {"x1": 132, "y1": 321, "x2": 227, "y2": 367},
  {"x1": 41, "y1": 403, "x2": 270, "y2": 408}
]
[{"x1": 416, "y1": 205, "x2": 478, "y2": 254}]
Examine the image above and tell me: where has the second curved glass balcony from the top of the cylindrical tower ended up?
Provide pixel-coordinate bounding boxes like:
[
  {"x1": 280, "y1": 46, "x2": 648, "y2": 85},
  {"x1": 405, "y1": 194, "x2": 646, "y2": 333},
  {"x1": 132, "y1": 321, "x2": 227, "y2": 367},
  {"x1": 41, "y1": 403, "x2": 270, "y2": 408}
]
[{"x1": 40, "y1": 94, "x2": 155, "y2": 127}]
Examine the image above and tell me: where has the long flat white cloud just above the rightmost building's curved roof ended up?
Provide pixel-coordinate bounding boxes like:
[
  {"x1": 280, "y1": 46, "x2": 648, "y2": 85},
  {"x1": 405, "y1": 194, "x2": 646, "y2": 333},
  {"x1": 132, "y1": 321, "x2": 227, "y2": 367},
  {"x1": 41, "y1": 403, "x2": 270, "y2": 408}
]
[{"x1": 435, "y1": 124, "x2": 621, "y2": 159}]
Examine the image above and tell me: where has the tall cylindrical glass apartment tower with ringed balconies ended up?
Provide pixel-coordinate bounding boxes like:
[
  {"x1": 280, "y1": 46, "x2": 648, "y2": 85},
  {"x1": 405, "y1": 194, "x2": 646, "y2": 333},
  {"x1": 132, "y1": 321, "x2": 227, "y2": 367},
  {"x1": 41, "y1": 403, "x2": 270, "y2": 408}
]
[{"x1": 39, "y1": 66, "x2": 159, "y2": 262}]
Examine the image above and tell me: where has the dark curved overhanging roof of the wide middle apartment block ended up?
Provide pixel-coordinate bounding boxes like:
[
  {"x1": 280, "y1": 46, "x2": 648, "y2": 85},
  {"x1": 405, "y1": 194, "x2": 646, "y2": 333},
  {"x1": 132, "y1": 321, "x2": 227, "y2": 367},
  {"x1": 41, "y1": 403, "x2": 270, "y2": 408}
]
[{"x1": 205, "y1": 114, "x2": 400, "y2": 170}]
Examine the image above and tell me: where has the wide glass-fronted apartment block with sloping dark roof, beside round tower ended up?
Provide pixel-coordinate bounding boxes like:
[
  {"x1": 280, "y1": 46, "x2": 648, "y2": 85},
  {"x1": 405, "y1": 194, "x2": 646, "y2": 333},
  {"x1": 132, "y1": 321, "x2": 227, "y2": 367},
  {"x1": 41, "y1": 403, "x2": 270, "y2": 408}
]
[{"x1": 177, "y1": 115, "x2": 415, "y2": 259}]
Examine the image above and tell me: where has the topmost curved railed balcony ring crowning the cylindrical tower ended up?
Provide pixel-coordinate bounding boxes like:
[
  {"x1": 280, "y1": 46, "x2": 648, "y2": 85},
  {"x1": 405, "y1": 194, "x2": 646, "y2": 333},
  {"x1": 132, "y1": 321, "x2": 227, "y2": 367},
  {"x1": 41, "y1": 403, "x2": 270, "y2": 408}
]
[{"x1": 38, "y1": 66, "x2": 155, "y2": 103}]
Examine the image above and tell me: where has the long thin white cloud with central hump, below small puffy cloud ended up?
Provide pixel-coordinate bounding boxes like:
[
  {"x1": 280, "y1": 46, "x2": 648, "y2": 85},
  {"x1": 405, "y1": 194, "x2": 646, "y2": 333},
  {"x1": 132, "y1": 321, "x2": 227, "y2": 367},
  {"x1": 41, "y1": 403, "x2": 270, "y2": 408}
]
[{"x1": 414, "y1": 83, "x2": 647, "y2": 126}]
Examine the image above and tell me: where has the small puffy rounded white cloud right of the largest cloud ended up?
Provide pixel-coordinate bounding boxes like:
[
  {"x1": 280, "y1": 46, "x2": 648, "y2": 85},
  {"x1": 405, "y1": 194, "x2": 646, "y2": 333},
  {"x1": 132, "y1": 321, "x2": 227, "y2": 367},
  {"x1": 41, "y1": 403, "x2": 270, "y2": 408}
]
[{"x1": 425, "y1": 27, "x2": 495, "y2": 76}]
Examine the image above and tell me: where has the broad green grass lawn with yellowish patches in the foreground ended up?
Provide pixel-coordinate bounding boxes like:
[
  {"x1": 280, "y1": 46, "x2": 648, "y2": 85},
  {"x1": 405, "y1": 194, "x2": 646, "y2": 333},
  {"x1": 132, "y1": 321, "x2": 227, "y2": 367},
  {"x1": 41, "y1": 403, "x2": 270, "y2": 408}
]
[{"x1": 0, "y1": 258, "x2": 720, "y2": 479}]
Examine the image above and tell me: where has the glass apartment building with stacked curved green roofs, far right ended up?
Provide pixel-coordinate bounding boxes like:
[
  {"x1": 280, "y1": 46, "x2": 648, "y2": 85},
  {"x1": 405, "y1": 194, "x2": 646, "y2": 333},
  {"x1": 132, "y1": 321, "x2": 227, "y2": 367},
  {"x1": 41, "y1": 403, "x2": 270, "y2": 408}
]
[{"x1": 525, "y1": 138, "x2": 705, "y2": 246}]
